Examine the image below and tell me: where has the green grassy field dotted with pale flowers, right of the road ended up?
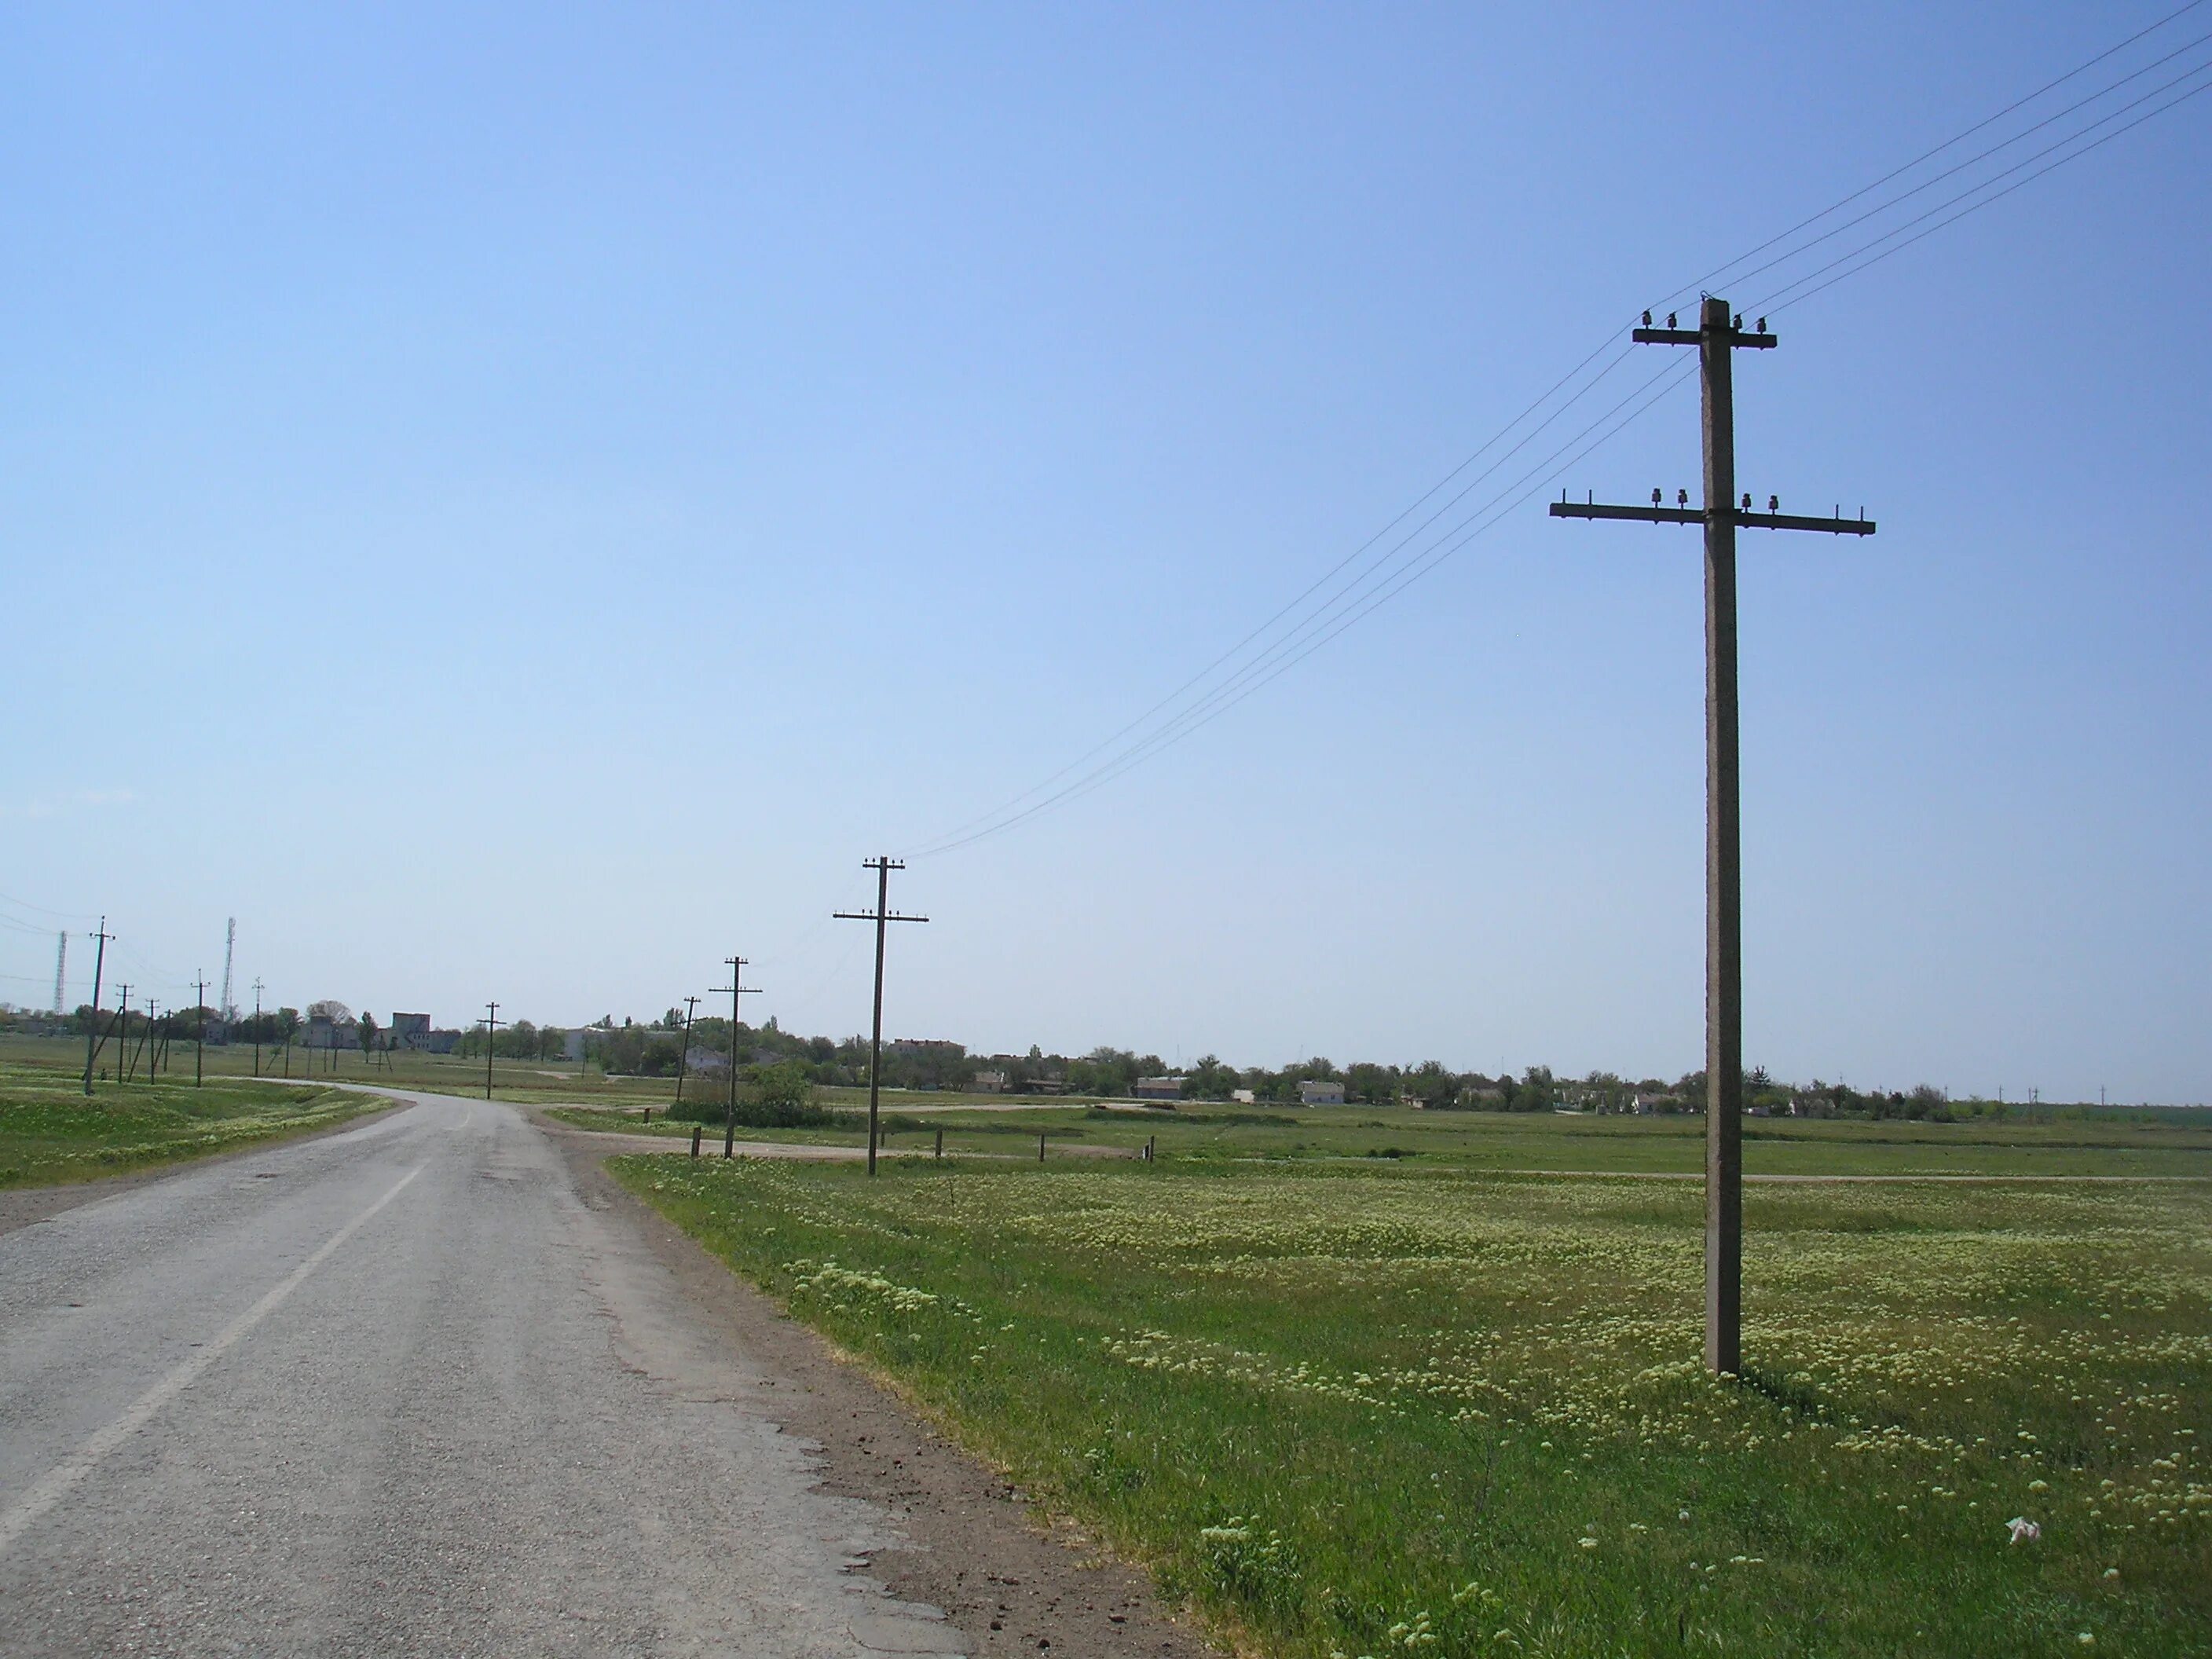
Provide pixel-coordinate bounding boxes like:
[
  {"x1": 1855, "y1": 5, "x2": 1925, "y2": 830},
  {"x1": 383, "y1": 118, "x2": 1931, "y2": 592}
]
[{"x1": 615, "y1": 1159, "x2": 2212, "y2": 1659}]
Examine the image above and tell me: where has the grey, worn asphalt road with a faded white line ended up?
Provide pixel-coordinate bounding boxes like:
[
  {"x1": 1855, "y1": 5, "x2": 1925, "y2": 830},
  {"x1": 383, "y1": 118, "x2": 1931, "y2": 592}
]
[{"x1": 0, "y1": 1095, "x2": 969, "y2": 1659}]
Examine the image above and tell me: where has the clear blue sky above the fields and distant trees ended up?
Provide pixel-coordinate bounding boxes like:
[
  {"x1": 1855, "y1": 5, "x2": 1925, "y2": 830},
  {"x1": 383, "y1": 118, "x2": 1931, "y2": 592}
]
[{"x1": 0, "y1": 0, "x2": 2212, "y2": 1100}]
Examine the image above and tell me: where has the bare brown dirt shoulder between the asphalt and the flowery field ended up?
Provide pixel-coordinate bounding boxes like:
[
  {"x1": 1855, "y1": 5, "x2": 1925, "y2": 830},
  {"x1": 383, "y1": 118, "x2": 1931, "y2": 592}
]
[{"x1": 535, "y1": 1117, "x2": 1219, "y2": 1659}]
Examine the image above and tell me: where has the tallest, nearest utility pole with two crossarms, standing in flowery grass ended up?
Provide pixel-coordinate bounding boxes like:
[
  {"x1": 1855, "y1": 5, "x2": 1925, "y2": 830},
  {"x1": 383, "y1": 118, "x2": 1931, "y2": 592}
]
[{"x1": 1551, "y1": 295, "x2": 1873, "y2": 1374}]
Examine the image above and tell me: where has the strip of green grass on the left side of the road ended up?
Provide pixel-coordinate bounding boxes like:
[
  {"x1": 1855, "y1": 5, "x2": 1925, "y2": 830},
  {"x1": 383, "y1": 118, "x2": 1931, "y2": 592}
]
[{"x1": 0, "y1": 1062, "x2": 385, "y2": 1188}]
